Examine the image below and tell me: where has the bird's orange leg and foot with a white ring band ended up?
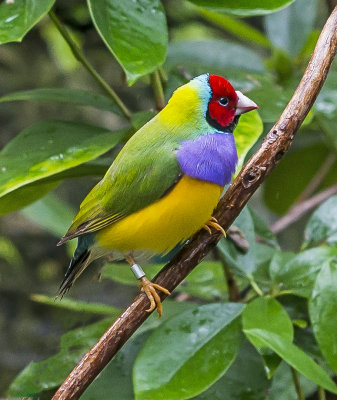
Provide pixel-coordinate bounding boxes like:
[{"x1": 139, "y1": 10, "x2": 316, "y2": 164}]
[{"x1": 125, "y1": 255, "x2": 171, "y2": 318}]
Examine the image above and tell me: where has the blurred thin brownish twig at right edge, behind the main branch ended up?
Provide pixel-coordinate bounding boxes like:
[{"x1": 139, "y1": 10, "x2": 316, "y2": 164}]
[{"x1": 270, "y1": 184, "x2": 337, "y2": 233}]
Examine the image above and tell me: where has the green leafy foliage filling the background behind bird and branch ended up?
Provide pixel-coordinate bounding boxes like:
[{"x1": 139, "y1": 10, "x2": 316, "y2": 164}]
[{"x1": 0, "y1": 0, "x2": 337, "y2": 400}]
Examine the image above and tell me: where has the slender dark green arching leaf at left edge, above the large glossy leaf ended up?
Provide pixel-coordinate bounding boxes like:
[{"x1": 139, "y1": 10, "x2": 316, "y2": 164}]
[{"x1": 0, "y1": 88, "x2": 121, "y2": 115}]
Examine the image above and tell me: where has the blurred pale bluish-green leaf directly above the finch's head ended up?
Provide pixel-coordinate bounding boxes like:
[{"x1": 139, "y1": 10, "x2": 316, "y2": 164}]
[{"x1": 166, "y1": 40, "x2": 264, "y2": 75}]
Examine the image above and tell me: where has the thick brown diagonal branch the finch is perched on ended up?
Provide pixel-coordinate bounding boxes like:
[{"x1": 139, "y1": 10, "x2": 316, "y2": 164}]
[{"x1": 53, "y1": 8, "x2": 337, "y2": 400}]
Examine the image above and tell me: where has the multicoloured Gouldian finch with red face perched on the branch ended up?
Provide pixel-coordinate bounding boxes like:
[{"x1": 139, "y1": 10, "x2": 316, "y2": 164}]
[{"x1": 59, "y1": 74, "x2": 258, "y2": 316}]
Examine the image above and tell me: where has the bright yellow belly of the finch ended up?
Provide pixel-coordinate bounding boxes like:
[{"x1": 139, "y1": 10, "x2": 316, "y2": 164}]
[{"x1": 96, "y1": 176, "x2": 222, "y2": 253}]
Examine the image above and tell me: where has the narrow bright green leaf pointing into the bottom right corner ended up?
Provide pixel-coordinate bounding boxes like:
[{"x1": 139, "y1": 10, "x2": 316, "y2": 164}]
[{"x1": 244, "y1": 329, "x2": 337, "y2": 393}]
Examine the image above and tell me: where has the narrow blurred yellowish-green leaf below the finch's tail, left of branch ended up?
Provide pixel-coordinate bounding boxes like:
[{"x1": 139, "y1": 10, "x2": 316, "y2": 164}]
[{"x1": 30, "y1": 294, "x2": 122, "y2": 318}]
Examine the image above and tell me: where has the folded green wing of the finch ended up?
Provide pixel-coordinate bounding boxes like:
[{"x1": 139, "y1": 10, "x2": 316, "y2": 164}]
[{"x1": 59, "y1": 126, "x2": 181, "y2": 244}]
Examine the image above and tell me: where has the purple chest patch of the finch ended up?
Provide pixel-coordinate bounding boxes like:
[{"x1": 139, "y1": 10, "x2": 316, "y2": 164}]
[{"x1": 177, "y1": 133, "x2": 238, "y2": 186}]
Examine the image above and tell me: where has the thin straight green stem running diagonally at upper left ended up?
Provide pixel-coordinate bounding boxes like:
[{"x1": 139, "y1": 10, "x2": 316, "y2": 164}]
[{"x1": 49, "y1": 11, "x2": 131, "y2": 119}]
